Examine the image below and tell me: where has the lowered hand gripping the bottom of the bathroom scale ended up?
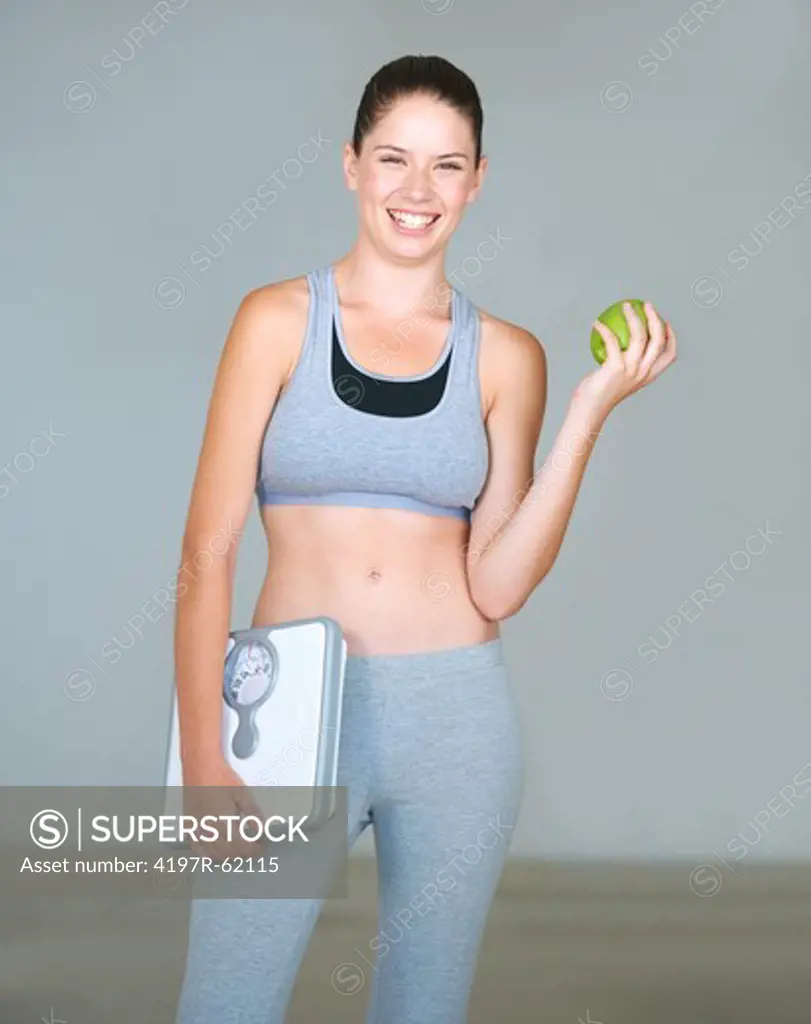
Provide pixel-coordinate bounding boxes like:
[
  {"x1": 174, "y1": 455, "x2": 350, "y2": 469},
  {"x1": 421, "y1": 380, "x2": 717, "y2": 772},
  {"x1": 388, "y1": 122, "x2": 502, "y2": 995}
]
[{"x1": 183, "y1": 756, "x2": 265, "y2": 860}]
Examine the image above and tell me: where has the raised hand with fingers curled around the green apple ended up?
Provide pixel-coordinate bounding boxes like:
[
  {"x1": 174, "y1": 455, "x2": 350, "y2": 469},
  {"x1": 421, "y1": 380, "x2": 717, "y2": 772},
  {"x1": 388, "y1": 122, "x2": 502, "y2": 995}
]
[{"x1": 573, "y1": 302, "x2": 676, "y2": 419}]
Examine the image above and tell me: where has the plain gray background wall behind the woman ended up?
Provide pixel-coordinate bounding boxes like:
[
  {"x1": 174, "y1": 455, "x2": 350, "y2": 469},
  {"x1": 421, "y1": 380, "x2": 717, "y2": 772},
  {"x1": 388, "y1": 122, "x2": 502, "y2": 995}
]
[{"x1": 0, "y1": 0, "x2": 811, "y2": 863}]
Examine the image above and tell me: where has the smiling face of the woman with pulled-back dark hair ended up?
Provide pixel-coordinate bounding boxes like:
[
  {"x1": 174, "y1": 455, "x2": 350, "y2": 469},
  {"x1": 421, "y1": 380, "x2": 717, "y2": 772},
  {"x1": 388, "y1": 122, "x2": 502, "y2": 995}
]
[{"x1": 344, "y1": 94, "x2": 486, "y2": 261}]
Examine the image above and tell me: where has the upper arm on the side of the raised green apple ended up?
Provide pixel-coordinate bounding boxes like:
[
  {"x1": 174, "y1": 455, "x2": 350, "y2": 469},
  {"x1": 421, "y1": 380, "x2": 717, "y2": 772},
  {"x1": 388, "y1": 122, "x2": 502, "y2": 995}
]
[{"x1": 469, "y1": 322, "x2": 547, "y2": 552}]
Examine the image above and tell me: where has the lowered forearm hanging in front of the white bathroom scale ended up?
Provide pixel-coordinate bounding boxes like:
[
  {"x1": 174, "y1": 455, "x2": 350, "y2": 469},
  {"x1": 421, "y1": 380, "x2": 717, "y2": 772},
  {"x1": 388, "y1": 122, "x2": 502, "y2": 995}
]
[{"x1": 174, "y1": 556, "x2": 233, "y2": 765}]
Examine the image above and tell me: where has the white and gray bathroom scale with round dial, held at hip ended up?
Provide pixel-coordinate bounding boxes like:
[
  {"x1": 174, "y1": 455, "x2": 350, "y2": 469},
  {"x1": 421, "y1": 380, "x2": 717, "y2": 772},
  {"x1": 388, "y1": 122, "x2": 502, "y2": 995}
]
[{"x1": 165, "y1": 616, "x2": 346, "y2": 829}]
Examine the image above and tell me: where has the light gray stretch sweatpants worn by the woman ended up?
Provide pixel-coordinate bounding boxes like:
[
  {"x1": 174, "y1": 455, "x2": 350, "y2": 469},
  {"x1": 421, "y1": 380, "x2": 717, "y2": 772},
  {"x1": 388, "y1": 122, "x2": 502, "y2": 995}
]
[{"x1": 177, "y1": 639, "x2": 523, "y2": 1024}]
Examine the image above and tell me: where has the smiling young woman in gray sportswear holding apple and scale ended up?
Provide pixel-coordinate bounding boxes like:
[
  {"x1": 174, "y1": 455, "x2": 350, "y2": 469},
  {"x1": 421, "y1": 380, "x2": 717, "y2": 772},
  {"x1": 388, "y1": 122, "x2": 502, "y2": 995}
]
[{"x1": 176, "y1": 56, "x2": 676, "y2": 1024}]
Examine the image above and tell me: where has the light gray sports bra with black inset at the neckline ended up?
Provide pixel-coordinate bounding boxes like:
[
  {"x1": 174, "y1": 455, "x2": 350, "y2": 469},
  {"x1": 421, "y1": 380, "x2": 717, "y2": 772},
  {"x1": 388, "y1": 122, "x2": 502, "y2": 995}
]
[{"x1": 256, "y1": 264, "x2": 488, "y2": 519}]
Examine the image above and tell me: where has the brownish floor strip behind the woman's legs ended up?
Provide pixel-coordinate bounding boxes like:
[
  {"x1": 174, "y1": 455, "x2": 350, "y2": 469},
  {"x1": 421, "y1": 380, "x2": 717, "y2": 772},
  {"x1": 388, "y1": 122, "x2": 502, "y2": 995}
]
[{"x1": 0, "y1": 858, "x2": 811, "y2": 1024}]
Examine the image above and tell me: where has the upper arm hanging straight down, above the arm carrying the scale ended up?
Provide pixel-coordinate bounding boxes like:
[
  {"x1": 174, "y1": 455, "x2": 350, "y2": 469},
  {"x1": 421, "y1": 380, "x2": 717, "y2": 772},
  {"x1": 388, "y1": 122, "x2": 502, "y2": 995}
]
[{"x1": 183, "y1": 282, "x2": 306, "y2": 561}]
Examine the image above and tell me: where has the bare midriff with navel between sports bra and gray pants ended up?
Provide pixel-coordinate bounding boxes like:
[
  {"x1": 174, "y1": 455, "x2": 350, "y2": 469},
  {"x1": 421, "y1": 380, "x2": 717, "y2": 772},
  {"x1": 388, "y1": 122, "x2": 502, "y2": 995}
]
[{"x1": 252, "y1": 505, "x2": 499, "y2": 655}]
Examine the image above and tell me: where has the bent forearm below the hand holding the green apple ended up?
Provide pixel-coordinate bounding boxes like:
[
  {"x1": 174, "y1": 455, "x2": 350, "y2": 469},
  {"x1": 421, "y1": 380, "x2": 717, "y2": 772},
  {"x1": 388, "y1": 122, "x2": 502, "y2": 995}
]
[{"x1": 468, "y1": 401, "x2": 605, "y2": 620}]
